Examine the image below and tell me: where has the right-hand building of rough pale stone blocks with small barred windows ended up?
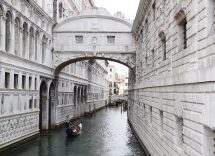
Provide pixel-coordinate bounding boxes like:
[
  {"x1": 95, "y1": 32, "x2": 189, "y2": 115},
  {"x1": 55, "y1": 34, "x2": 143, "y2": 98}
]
[{"x1": 128, "y1": 0, "x2": 215, "y2": 156}]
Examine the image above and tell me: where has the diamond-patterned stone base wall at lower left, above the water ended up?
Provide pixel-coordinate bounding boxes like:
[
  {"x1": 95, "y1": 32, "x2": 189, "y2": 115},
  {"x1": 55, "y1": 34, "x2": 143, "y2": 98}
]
[{"x1": 0, "y1": 111, "x2": 39, "y2": 149}]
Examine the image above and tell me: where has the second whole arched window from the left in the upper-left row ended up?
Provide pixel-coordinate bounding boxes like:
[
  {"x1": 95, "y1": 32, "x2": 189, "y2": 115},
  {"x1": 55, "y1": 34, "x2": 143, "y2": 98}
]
[{"x1": 15, "y1": 17, "x2": 20, "y2": 55}]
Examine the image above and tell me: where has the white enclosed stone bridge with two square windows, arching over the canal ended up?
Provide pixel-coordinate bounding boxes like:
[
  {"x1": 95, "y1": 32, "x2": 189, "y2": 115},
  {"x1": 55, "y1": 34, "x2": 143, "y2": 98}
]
[{"x1": 53, "y1": 8, "x2": 136, "y2": 77}]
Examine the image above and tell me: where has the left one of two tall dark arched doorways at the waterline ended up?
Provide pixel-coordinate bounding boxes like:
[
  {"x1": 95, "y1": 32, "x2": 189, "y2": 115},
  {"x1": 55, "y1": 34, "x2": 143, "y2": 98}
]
[{"x1": 39, "y1": 81, "x2": 48, "y2": 132}]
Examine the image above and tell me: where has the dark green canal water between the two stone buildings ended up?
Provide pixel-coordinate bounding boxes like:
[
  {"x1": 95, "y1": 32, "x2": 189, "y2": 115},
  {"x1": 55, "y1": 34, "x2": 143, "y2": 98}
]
[{"x1": 6, "y1": 107, "x2": 145, "y2": 156}]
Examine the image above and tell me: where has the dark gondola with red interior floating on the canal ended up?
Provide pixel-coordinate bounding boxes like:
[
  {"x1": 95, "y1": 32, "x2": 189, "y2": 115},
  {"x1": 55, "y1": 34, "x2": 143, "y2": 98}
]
[{"x1": 66, "y1": 122, "x2": 82, "y2": 136}]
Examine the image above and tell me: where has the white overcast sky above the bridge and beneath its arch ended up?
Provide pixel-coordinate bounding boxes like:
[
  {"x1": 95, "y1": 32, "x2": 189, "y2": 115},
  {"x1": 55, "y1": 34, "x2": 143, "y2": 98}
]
[{"x1": 94, "y1": 0, "x2": 140, "y2": 75}]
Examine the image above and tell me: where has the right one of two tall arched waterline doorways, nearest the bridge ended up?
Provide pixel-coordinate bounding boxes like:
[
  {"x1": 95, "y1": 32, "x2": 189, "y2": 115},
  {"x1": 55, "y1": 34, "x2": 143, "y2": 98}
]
[{"x1": 48, "y1": 82, "x2": 56, "y2": 129}]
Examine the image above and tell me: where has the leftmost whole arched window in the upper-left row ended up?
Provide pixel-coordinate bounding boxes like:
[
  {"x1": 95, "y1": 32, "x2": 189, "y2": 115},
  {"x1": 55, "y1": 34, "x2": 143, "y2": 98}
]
[{"x1": 5, "y1": 11, "x2": 12, "y2": 52}]
